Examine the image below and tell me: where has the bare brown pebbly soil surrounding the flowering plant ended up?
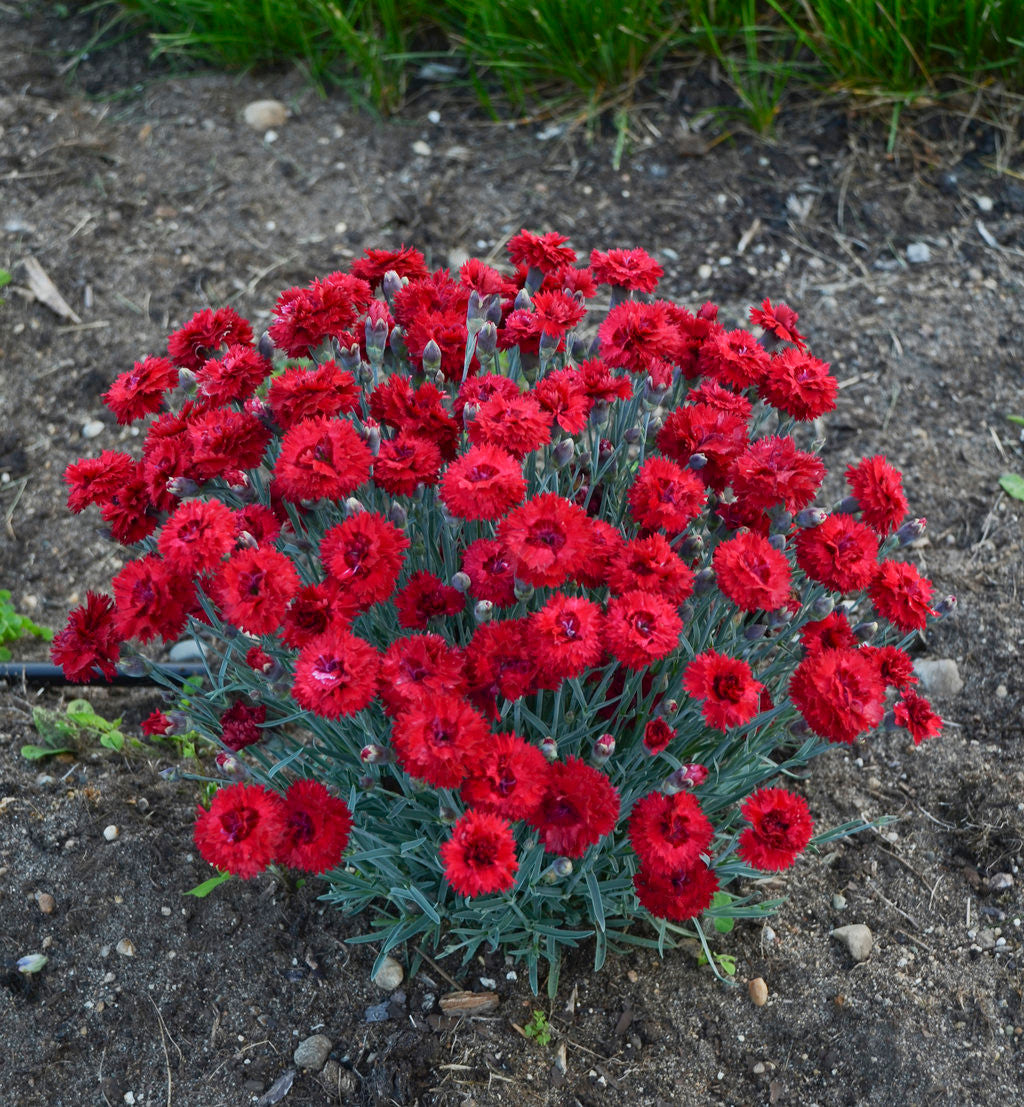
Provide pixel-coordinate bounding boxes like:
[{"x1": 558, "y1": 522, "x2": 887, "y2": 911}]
[{"x1": 0, "y1": 3, "x2": 1024, "y2": 1107}]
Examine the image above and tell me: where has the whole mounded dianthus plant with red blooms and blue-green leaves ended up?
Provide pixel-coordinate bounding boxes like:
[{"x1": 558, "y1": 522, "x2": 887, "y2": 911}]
[{"x1": 53, "y1": 230, "x2": 953, "y2": 990}]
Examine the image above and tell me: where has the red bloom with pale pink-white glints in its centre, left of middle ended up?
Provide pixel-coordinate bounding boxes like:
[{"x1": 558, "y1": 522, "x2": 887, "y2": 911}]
[{"x1": 291, "y1": 625, "x2": 380, "y2": 718}]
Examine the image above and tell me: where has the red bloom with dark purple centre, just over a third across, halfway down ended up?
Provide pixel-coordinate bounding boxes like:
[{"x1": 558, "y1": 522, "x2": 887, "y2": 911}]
[{"x1": 320, "y1": 511, "x2": 408, "y2": 609}]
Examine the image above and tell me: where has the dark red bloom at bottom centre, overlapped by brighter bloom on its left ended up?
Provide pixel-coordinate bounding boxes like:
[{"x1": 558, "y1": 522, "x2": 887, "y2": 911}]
[{"x1": 527, "y1": 757, "x2": 619, "y2": 857}]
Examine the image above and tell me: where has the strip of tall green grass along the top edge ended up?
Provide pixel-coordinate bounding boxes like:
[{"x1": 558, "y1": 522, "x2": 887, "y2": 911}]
[{"x1": 94, "y1": 0, "x2": 1024, "y2": 130}]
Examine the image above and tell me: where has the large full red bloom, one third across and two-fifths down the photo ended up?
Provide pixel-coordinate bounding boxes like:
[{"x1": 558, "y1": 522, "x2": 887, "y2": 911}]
[{"x1": 273, "y1": 416, "x2": 373, "y2": 501}]
